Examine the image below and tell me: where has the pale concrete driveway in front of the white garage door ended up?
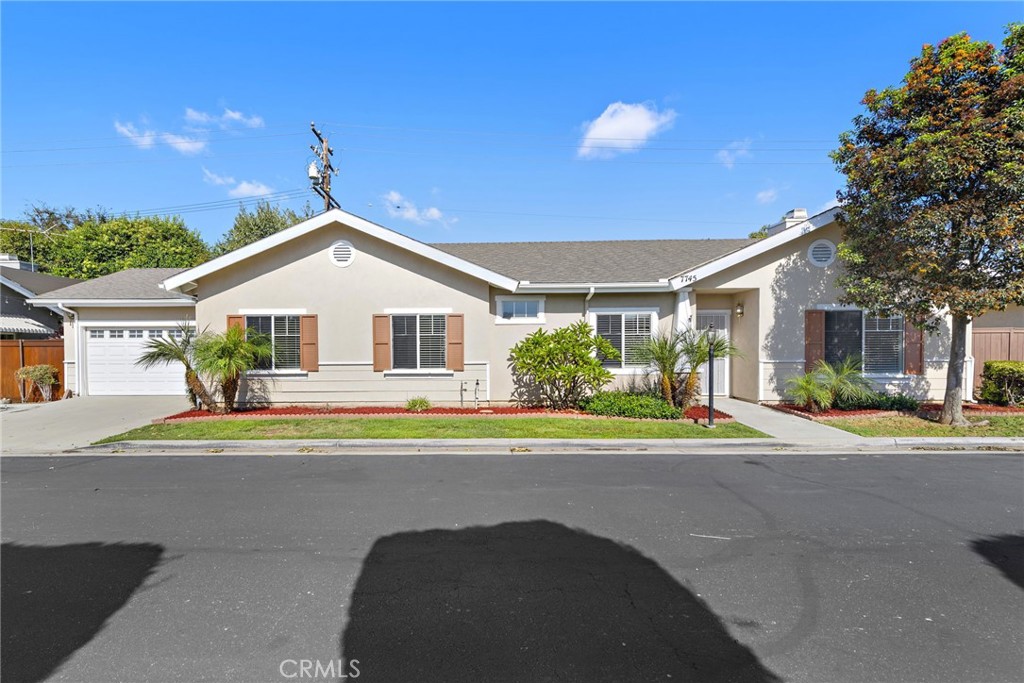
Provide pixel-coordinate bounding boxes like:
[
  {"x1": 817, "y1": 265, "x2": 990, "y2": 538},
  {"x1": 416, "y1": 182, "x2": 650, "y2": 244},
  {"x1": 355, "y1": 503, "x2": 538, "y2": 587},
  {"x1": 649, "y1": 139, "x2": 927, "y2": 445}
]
[{"x1": 0, "y1": 396, "x2": 188, "y2": 456}]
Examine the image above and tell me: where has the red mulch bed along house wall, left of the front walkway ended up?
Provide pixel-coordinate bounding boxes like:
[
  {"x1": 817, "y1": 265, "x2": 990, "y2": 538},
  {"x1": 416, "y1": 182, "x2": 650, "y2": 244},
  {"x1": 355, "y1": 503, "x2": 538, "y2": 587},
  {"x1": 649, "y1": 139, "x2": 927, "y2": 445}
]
[{"x1": 157, "y1": 405, "x2": 732, "y2": 422}]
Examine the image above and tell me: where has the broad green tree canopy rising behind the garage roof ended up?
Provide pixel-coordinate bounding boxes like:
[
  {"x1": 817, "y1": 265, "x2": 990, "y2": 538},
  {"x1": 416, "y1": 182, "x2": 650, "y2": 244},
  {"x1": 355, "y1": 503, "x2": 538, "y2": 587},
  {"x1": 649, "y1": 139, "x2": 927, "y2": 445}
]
[{"x1": 45, "y1": 216, "x2": 210, "y2": 278}]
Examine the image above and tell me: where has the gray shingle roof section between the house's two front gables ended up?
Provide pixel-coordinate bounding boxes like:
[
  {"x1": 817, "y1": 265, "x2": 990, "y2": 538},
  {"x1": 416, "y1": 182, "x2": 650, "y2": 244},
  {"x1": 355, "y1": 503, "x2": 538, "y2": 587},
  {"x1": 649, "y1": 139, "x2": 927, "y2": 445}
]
[{"x1": 430, "y1": 240, "x2": 757, "y2": 283}]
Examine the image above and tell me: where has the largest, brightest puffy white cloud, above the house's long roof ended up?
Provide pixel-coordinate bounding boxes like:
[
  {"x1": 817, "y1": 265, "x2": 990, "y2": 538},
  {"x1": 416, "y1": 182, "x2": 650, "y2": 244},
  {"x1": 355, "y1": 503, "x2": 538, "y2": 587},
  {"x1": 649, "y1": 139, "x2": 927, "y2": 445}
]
[{"x1": 577, "y1": 102, "x2": 676, "y2": 159}]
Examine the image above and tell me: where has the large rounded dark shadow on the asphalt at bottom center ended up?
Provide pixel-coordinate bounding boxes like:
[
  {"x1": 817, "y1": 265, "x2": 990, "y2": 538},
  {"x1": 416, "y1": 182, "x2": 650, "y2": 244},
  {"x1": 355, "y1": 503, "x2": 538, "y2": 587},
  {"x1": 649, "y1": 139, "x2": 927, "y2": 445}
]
[{"x1": 340, "y1": 520, "x2": 780, "y2": 683}]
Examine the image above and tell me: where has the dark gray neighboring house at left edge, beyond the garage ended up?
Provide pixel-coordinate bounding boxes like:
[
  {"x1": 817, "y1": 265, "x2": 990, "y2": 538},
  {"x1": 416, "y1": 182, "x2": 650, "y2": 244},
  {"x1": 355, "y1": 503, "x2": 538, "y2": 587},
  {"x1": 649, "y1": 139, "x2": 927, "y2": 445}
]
[{"x1": 0, "y1": 254, "x2": 82, "y2": 339}]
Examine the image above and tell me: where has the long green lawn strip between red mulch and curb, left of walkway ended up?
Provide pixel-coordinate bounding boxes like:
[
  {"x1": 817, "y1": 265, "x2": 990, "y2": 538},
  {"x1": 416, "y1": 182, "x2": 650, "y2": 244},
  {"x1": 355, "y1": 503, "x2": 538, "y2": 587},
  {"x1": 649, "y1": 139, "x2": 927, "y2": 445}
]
[{"x1": 97, "y1": 418, "x2": 769, "y2": 443}]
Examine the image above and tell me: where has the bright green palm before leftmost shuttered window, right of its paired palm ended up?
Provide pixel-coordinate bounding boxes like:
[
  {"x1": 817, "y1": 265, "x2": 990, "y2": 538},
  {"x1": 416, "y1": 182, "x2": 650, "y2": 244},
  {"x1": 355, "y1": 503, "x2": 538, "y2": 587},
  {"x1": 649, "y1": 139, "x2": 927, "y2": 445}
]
[{"x1": 196, "y1": 327, "x2": 273, "y2": 413}]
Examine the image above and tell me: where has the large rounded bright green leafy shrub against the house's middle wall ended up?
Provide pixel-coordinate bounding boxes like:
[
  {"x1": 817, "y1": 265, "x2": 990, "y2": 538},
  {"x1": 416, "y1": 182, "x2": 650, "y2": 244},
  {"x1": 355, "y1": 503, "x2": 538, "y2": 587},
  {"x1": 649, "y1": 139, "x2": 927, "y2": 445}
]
[{"x1": 509, "y1": 321, "x2": 618, "y2": 410}]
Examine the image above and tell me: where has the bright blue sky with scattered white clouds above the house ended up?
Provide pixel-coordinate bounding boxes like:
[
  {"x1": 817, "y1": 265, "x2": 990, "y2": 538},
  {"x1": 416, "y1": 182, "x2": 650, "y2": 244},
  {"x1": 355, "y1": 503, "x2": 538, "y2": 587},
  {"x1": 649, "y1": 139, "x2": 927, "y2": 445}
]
[{"x1": 0, "y1": 2, "x2": 1021, "y2": 242}]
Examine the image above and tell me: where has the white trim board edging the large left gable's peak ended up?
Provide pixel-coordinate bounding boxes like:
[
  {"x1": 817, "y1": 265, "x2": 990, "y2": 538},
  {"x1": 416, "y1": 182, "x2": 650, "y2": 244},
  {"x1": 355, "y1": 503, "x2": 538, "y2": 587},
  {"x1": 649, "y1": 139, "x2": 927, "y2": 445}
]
[{"x1": 163, "y1": 209, "x2": 519, "y2": 292}]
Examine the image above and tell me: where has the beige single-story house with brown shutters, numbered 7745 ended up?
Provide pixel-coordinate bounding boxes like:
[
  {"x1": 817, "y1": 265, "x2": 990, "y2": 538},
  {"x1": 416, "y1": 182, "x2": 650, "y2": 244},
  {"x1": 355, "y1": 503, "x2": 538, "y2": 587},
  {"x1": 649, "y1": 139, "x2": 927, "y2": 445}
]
[{"x1": 25, "y1": 209, "x2": 1024, "y2": 403}]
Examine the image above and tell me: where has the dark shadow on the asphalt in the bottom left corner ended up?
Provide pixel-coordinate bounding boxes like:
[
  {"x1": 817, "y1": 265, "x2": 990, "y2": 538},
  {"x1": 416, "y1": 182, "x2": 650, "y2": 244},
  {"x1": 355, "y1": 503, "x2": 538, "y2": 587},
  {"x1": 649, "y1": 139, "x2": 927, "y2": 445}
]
[{"x1": 0, "y1": 543, "x2": 164, "y2": 683}]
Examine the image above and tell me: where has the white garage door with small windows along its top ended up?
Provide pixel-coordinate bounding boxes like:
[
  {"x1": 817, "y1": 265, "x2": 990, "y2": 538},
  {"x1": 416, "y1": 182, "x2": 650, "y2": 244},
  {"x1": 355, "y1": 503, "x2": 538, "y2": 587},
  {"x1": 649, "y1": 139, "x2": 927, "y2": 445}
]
[{"x1": 86, "y1": 325, "x2": 185, "y2": 396}]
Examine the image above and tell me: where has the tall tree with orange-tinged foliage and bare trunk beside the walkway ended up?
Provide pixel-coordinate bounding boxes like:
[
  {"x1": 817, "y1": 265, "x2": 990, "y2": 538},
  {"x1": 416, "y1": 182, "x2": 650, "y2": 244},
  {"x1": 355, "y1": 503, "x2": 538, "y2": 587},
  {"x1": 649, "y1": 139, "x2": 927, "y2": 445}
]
[{"x1": 831, "y1": 25, "x2": 1024, "y2": 425}]
